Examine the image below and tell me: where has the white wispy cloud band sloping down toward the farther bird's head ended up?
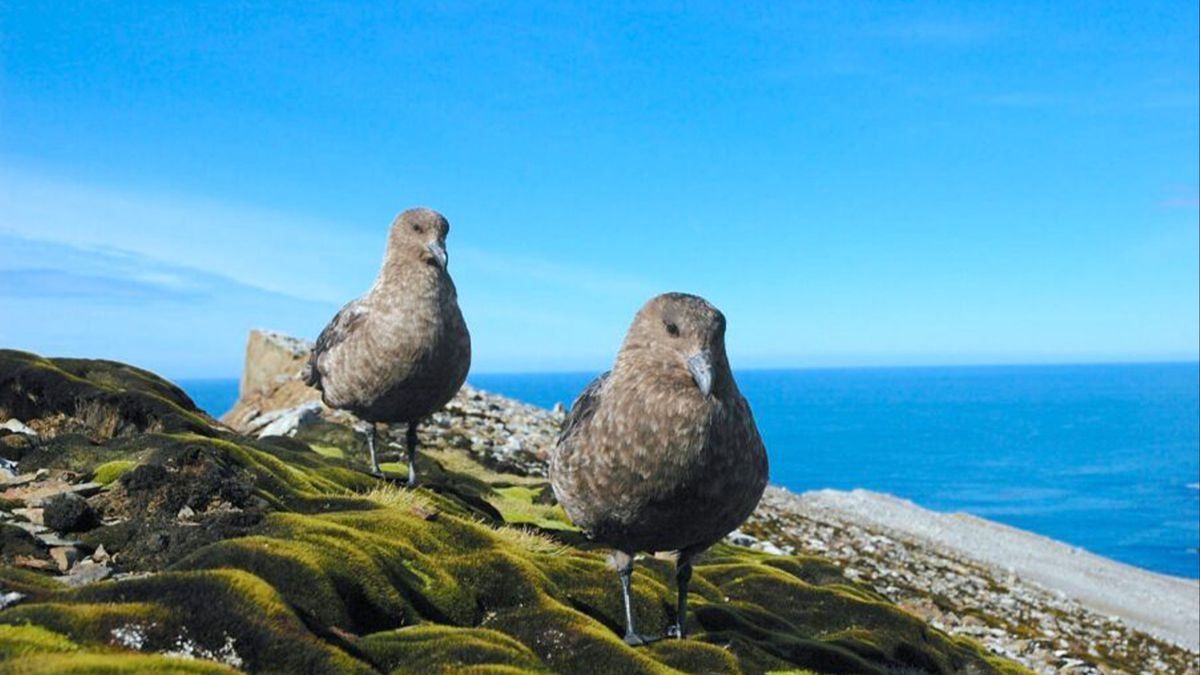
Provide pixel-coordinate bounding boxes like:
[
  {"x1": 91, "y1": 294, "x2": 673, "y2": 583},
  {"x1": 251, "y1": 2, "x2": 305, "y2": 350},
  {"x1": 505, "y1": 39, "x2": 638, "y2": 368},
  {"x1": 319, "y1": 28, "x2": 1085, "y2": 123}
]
[{"x1": 0, "y1": 166, "x2": 382, "y2": 301}]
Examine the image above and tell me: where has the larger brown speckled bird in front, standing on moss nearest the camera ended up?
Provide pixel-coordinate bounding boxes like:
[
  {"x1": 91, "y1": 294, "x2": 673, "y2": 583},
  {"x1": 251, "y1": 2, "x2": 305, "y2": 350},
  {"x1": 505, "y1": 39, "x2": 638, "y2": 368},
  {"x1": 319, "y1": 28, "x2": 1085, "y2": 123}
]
[{"x1": 550, "y1": 293, "x2": 767, "y2": 644}]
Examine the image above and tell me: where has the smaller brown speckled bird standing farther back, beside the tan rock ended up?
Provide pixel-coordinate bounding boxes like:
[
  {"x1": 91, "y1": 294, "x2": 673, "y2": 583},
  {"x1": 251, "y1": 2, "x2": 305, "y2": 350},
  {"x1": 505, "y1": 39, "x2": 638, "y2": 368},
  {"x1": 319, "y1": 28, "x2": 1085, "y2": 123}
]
[{"x1": 305, "y1": 209, "x2": 470, "y2": 480}]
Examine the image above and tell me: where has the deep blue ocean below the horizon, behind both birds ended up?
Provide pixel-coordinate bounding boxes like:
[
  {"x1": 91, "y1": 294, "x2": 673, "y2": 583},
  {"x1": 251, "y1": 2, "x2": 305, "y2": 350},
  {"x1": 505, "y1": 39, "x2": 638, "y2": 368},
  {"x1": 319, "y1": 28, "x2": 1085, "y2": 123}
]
[{"x1": 181, "y1": 363, "x2": 1200, "y2": 578}]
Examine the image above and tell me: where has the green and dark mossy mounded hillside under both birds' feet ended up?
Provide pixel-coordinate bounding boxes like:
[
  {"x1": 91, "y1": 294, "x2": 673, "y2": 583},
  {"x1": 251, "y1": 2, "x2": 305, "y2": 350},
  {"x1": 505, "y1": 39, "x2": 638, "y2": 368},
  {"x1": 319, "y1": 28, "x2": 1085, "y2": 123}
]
[{"x1": 0, "y1": 351, "x2": 1020, "y2": 673}]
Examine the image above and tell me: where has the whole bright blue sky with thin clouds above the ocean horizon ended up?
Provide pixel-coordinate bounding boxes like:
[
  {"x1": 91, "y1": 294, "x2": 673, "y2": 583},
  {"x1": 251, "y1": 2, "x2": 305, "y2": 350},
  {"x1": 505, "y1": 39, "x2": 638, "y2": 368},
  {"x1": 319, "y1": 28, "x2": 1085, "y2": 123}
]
[{"x1": 0, "y1": 1, "x2": 1200, "y2": 377}]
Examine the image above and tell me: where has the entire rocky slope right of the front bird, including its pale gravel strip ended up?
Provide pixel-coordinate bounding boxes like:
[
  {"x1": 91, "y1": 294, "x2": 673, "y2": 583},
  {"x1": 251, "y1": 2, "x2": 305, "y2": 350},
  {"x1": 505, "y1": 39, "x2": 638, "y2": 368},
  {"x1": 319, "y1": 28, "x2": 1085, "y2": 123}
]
[{"x1": 736, "y1": 486, "x2": 1200, "y2": 674}]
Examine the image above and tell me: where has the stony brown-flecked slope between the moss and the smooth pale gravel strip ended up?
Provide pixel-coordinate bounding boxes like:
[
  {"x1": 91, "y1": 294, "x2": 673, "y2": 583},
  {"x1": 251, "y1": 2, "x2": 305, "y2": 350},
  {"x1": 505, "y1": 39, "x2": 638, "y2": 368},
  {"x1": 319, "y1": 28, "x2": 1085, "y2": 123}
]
[{"x1": 731, "y1": 488, "x2": 1200, "y2": 675}]
